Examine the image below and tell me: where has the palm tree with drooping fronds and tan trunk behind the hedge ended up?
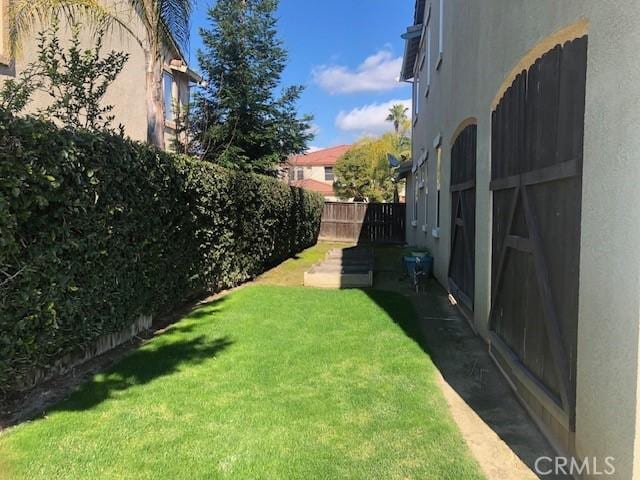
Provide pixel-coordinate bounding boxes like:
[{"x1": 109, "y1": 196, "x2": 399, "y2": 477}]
[{"x1": 8, "y1": 0, "x2": 193, "y2": 148}]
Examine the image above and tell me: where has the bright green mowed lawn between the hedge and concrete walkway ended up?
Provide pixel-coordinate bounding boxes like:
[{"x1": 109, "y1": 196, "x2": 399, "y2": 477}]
[{"x1": 0, "y1": 285, "x2": 481, "y2": 480}]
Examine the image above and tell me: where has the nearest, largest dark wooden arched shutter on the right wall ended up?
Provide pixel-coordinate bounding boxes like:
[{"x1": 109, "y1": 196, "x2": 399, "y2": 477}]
[{"x1": 490, "y1": 36, "x2": 587, "y2": 428}]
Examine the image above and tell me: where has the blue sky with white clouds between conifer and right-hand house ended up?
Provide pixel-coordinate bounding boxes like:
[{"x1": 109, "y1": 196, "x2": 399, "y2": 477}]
[{"x1": 190, "y1": 0, "x2": 414, "y2": 148}]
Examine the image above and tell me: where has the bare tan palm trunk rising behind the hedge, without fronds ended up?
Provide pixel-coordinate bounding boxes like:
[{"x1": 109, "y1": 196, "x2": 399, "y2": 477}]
[{"x1": 145, "y1": 44, "x2": 165, "y2": 150}]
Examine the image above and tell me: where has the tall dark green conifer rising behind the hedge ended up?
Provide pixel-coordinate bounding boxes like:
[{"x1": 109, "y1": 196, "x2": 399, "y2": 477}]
[{"x1": 192, "y1": 0, "x2": 312, "y2": 174}]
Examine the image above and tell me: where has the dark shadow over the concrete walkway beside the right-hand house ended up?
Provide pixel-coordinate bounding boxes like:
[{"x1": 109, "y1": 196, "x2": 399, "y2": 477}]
[{"x1": 364, "y1": 248, "x2": 568, "y2": 479}]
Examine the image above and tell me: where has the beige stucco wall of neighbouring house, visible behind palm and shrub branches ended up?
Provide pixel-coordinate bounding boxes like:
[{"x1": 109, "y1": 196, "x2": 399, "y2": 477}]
[{"x1": 0, "y1": 0, "x2": 189, "y2": 147}]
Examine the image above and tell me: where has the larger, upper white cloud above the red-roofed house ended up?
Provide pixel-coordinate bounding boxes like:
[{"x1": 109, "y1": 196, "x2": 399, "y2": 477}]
[{"x1": 312, "y1": 48, "x2": 402, "y2": 95}]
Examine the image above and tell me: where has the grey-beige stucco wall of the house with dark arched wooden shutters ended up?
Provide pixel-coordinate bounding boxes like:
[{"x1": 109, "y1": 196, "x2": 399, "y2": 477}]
[{"x1": 407, "y1": 0, "x2": 640, "y2": 480}]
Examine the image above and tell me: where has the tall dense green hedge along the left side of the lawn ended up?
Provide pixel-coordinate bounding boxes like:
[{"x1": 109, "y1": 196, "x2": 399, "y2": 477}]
[{"x1": 0, "y1": 113, "x2": 322, "y2": 394}]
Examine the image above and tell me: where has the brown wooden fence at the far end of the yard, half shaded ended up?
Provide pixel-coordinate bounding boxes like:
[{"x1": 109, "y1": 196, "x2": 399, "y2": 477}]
[{"x1": 319, "y1": 202, "x2": 405, "y2": 243}]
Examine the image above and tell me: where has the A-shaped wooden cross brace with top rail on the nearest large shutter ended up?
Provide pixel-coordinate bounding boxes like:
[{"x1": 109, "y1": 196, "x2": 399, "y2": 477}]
[{"x1": 489, "y1": 160, "x2": 578, "y2": 412}]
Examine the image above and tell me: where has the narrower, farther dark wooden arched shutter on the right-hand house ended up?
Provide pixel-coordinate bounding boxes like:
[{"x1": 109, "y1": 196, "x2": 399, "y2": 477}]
[{"x1": 449, "y1": 125, "x2": 477, "y2": 311}]
